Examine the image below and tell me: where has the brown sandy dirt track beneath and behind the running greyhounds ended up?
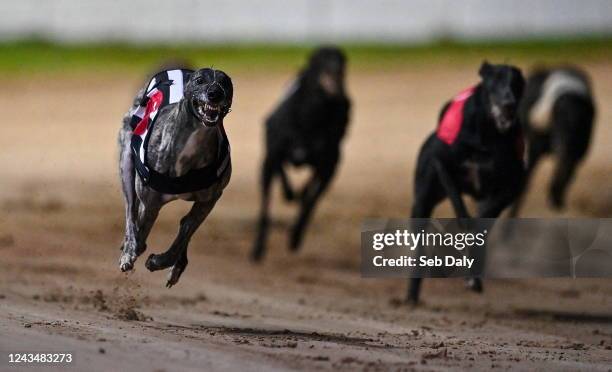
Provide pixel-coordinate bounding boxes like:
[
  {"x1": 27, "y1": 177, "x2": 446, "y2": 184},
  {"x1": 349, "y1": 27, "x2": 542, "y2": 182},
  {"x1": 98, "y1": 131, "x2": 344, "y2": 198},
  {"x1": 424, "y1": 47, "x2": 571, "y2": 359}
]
[{"x1": 0, "y1": 63, "x2": 612, "y2": 371}]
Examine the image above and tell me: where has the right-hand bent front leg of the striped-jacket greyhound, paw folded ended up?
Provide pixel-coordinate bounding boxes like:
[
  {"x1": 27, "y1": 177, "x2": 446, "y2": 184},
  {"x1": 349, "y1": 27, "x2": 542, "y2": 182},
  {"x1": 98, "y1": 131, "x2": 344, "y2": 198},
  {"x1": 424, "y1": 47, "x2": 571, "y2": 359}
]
[{"x1": 145, "y1": 198, "x2": 218, "y2": 287}]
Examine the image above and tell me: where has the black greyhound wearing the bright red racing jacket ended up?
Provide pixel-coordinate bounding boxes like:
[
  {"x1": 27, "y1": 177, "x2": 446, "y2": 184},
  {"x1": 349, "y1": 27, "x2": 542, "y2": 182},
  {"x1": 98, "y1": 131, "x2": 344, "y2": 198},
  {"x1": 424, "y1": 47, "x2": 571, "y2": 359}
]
[{"x1": 408, "y1": 61, "x2": 525, "y2": 303}]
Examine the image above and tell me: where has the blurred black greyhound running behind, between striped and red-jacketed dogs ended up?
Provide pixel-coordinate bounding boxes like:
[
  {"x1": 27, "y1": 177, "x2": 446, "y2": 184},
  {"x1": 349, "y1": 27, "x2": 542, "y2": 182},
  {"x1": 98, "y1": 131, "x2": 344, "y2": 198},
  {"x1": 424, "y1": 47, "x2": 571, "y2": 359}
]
[{"x1": 252, "y1": 47, "x2": 350, "y2": 261}]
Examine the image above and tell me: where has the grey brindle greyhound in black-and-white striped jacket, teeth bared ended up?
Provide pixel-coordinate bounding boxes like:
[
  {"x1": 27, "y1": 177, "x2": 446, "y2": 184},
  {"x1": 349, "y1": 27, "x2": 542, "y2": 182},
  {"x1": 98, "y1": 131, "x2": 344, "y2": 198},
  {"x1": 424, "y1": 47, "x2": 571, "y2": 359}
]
[{"x1": 119, "y1": 68, "x2": 233, "y2": 287}]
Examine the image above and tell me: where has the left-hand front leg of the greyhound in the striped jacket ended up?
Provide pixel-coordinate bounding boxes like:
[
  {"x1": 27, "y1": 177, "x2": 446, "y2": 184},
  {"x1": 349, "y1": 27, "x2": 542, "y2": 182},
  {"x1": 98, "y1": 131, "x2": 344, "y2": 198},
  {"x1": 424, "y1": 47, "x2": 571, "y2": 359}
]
[{"x1": 119, "y1": 197, "x2": 163, "y2": 271}]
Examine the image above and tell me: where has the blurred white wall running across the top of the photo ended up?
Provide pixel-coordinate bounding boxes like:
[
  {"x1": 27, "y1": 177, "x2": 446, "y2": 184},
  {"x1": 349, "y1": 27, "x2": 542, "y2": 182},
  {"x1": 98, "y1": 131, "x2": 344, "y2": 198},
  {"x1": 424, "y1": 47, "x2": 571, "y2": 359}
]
[{"x1": 0, "y1": 0, "x2": 612, "y2": 42}]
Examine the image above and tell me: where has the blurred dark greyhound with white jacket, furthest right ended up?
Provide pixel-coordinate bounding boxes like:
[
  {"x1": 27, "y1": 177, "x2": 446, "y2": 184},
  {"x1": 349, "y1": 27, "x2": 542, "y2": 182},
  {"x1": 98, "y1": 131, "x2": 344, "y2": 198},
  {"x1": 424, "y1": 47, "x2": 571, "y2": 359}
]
[{"x1": 510, "y1": 67, "x2": 595, "y2": 217}]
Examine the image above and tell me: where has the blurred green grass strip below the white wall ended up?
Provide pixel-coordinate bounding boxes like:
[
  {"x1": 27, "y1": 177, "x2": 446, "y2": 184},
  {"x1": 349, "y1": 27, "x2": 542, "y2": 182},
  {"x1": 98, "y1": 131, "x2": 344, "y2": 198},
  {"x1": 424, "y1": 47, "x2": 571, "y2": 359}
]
[{"x1": 0, "y1": 37, "x2": 612, "y2": 75}]
